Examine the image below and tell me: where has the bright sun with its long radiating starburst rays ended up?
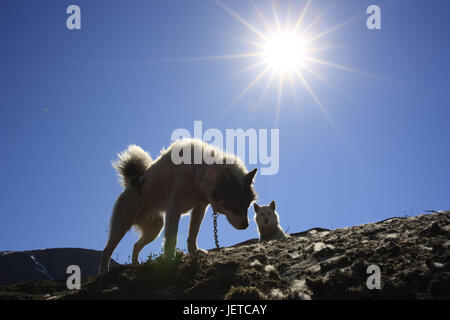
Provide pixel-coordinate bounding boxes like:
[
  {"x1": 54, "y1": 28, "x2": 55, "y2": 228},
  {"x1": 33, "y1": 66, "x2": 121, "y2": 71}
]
[{"x1": 201, "y1": 0, "x2": 363, "y2": 124}]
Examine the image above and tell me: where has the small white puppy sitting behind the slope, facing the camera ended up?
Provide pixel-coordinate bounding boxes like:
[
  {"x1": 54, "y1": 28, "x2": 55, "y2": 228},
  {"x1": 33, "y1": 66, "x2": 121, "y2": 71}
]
[{"x1": 253, "y1": 201, "x2": 286, "y2": 242}]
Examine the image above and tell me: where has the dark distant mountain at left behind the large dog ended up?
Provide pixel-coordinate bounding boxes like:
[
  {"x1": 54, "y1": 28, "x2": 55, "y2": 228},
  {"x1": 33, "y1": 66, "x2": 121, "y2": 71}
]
[{"x1": 0, "y1": 248, "x2": 119, "y2": 285}]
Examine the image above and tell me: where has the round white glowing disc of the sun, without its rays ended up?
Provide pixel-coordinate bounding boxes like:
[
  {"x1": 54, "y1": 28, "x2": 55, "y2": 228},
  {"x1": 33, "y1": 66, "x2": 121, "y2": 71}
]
[{"x1": 264, "y1": 33, "x2": 304, "y2": 73}]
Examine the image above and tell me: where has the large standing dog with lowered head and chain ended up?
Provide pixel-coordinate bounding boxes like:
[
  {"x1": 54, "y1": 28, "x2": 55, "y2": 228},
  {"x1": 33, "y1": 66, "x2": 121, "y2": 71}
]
[{"x1": 100, "y1": 139, "x2": 257, "y2": 272}]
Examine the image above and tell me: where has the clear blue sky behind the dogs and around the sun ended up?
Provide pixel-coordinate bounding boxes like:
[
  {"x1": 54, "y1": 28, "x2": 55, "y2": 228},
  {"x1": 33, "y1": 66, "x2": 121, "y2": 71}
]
[{"x1": 0, "y1": 0, "x2": 450, "y2": 262}]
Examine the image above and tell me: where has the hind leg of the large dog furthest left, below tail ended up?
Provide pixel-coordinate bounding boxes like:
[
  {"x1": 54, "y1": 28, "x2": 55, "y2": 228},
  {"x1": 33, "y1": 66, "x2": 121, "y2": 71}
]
[{"x1": 100, "y1": 190, "x2": 139, "y2": 273}]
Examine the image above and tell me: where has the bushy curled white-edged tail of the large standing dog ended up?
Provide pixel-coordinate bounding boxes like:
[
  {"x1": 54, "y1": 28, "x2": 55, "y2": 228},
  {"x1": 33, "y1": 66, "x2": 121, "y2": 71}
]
[{"x1": 112, "y1": 144, "x2": 152, "y2": 187}]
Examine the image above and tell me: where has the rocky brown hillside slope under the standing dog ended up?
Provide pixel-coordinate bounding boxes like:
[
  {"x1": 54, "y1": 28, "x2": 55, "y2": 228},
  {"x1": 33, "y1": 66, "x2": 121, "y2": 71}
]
[{"x1": 0, "y1": 212, "x2": 450, "y2": 299}]
